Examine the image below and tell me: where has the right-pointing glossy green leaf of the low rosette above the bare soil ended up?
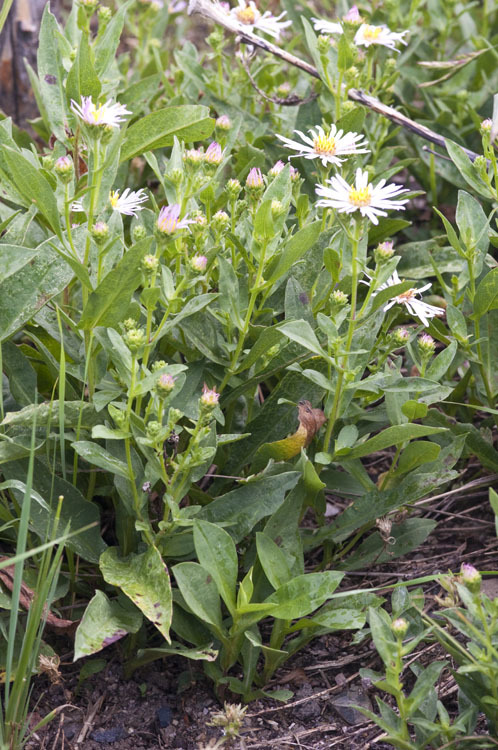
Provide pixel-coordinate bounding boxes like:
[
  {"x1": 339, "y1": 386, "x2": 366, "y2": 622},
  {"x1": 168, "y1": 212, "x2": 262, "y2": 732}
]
[{"x1": 265, "y1": 570, "x2": 344, "y2": 620}]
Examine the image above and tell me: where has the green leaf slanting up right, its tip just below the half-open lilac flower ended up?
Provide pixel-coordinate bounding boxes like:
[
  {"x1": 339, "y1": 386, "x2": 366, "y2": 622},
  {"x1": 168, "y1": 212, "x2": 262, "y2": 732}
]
[{"x1": 78, "y1": 237, "x2": 152, "y2": 330}]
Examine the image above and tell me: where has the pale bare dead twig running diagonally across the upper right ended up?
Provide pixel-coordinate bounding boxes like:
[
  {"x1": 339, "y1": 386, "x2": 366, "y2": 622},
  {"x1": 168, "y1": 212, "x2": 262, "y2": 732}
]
[{"x1": 188, "y1": 0, "x2": 479, "y2": 161}]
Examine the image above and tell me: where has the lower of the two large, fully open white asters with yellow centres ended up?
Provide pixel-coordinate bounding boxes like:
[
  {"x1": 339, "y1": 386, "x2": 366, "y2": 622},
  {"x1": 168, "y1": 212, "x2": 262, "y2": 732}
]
[{"x1": 316, "y1": 168, "x2": 409, "y2": 224}]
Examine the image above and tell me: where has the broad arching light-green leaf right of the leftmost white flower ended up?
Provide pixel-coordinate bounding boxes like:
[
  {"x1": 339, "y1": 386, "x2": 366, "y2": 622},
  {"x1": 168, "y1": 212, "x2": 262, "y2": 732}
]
[{"x1": 120, "y1": 104, "x2": 214, "y2": 163}]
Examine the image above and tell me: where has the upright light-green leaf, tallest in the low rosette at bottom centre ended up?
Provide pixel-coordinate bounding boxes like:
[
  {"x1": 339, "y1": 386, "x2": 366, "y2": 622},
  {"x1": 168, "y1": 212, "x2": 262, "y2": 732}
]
[{"x1": 194, "y1": 521, "x2": 238, "y2": 614}]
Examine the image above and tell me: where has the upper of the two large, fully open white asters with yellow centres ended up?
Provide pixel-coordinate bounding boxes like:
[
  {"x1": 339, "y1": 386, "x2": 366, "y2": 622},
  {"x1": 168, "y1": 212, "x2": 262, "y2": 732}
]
[{"x1": 277, "y1": 125, "x2": 369, "y2": 167}]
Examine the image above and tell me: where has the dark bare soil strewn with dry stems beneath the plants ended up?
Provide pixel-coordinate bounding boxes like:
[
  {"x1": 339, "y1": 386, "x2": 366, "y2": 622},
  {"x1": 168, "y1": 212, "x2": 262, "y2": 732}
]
[{"x1": 28, "y1": 475, "x2": 498, "y2": 750}]
